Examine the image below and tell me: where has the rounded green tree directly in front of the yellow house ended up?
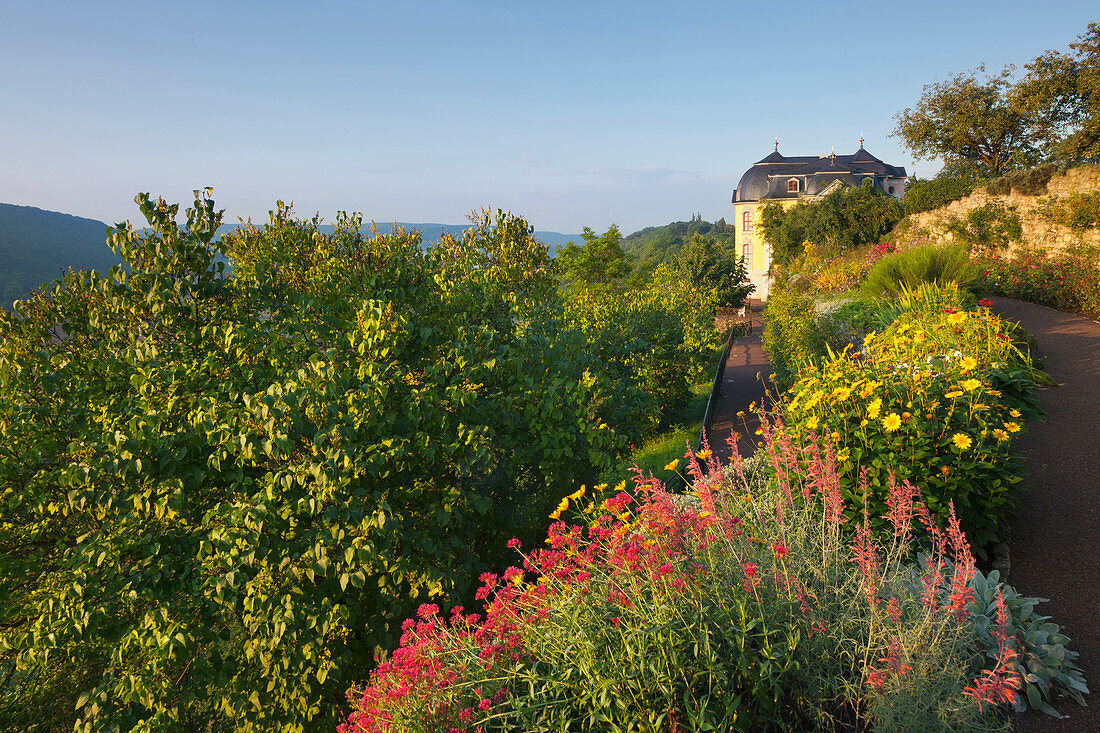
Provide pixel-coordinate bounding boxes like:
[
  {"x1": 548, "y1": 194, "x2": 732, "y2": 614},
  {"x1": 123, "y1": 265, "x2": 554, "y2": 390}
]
[{"x1": 758, "y1": 182, "x2": 903, "y2": 264}]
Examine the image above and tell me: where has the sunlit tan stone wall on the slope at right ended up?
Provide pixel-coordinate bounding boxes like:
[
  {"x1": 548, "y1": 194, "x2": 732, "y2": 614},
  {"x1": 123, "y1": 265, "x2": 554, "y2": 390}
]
[{"x1": 909, "y1": 165, "x2": 1100, "y2": 252}]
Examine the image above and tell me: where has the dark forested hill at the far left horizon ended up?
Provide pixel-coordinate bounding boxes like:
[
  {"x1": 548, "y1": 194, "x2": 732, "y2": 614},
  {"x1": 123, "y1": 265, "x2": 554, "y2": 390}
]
[{"x1": 0, "y1": 204, "x2": 120, "y2": 309}]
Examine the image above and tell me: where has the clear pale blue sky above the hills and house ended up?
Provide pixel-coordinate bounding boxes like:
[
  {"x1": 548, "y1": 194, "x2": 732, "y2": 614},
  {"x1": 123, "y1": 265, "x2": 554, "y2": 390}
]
[{"x1": 0, "y1": 0, "x2": 1100, "y2": 232}]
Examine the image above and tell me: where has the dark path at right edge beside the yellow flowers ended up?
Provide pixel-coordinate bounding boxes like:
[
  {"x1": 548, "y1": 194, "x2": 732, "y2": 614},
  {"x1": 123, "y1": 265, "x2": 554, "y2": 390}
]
[{"x1": 992, "y1": 298, "x2": 1100, "y2": 733}]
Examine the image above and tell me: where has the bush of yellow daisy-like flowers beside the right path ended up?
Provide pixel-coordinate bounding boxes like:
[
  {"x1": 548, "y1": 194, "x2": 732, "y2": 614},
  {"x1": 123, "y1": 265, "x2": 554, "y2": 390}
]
[{"x1": 776, "y1": 295, "x2": 1045, "y2": 549}]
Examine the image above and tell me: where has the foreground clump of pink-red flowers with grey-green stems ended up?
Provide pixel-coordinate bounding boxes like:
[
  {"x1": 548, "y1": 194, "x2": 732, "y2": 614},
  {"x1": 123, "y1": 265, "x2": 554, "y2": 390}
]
[{"x1": 341, "y1": 428, "x2": 1069, "y2": 733}]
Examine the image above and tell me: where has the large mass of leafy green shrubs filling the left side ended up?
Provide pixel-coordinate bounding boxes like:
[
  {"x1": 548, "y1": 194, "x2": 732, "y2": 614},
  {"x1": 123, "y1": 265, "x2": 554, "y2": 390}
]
[{"x1": 0, "y1": 192, "x2": 619, "y2": 731}]
